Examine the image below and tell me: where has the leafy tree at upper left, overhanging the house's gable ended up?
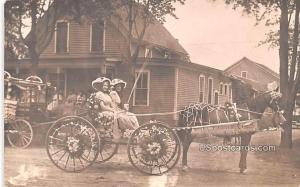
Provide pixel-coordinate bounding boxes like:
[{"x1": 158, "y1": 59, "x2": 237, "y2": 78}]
[{"x1": 4, "y1": 0, "x2": 113, "y2": 74}]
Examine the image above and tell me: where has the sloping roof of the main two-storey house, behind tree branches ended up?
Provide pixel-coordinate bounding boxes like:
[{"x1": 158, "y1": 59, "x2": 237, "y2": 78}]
[{"x1": 110, "y1": 7, "x2": 188, "y2": 55}]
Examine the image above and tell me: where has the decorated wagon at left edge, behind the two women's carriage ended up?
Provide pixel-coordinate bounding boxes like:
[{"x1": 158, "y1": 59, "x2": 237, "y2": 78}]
[{"x1": 4, "y1": 72, "x2": 53, "y2": 148}]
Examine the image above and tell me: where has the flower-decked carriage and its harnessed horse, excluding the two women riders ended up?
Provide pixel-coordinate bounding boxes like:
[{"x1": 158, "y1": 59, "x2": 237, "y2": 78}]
[{"x1": 46, "y1": 86, "x2": 279, "y2": 175}]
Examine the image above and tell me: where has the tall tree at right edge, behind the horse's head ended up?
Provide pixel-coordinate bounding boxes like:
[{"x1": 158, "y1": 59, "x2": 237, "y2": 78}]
[{"x1": 213, "y1": 0, "x2": 300, "y2": 147}]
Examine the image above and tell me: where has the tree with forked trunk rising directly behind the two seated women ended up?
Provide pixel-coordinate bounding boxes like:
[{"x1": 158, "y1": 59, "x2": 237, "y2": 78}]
[{"x1": 116, "y1": 0, "x2": 185, "y2": 102}]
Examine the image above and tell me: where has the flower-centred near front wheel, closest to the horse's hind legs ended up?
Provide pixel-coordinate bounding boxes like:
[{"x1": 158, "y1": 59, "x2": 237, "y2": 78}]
[{"x1": 127, "y1": 122, "x2": 181, "y2": 175}]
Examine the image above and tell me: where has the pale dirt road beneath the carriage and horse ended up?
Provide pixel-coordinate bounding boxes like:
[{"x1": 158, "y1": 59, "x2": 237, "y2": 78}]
[{"x1": 4, "y1": 130, "x2": 300, "y2": 187}]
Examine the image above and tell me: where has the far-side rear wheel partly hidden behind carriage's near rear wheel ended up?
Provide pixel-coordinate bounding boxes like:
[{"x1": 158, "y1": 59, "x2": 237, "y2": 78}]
[{"x1": 96, "y1": 138, "x2": 119, "y2": 164}]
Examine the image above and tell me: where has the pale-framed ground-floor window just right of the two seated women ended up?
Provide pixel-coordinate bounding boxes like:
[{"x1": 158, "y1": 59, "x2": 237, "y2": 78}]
[{"x1": 133, "y1": 71, "x2": 150, "y2": 106}]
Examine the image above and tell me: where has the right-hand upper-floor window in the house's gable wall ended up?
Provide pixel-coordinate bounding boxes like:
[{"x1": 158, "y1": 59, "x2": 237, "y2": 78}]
[{"x1": 90, "y1": 21, "x2": 104, "y2": 52}]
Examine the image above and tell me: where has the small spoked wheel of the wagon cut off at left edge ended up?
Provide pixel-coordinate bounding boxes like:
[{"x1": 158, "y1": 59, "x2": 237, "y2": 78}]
[{"x1": 7, "y1": 119, "x2": 33, "y2": 148}]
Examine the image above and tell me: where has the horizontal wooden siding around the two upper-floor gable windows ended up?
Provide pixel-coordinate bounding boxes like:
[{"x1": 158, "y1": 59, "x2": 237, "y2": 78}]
[{"x1": 41, "y1": 21, "x2": 126, "y2": 58}]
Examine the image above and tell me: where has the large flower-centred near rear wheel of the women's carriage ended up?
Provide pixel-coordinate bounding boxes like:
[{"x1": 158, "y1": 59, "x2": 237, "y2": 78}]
[{"x1": 46, "y1": 116, "x2": 100, "y2": 172}]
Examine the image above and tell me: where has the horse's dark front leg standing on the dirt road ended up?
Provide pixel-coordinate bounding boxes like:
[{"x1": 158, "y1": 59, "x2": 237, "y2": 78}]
[{"x1": 239, "y1": 134, "x2": 252, "y2": 173}]
